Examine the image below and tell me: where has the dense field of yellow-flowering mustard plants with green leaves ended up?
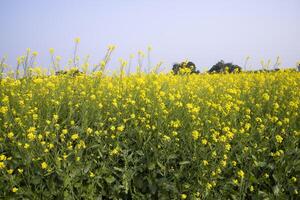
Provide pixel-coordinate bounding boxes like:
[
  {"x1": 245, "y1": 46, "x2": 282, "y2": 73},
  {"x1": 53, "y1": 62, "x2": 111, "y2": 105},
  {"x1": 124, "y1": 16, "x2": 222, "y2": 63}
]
[{"x1": 0, "y1": 70, "x2": 300, "y2": 199}]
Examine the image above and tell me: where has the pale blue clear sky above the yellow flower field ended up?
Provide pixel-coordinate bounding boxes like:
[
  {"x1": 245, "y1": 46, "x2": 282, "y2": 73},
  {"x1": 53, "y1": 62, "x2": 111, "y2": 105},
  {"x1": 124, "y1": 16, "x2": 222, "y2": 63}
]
[{"x1": 0, "y1": 0, "x2": 300, "y2": 71}]
